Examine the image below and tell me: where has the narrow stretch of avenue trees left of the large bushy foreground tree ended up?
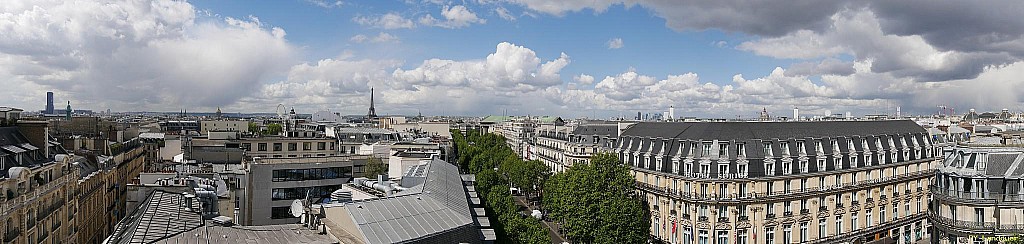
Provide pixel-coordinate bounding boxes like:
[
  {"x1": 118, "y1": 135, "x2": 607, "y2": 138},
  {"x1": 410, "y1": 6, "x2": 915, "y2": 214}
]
[{"x1": 452, "y1": 130, "x2": 551, "y2": 243}]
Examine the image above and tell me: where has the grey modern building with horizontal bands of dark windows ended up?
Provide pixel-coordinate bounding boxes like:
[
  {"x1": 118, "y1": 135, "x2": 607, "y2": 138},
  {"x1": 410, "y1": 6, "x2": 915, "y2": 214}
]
[{"x1": 238, "y1": 156, "x2": 368, "y2": 226}]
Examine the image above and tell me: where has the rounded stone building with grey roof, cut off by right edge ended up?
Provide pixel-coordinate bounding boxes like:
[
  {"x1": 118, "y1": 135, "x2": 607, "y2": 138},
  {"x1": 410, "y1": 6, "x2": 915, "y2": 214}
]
[{"x1": 929, "y1": 146, "x2": 1024, "y2": 244}]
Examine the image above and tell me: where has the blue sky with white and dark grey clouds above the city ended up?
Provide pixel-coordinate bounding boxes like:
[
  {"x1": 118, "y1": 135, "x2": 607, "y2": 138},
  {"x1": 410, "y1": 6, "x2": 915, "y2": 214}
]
[{"x1": 0, "y1": 0, "x2": 1024, "y2": 118}]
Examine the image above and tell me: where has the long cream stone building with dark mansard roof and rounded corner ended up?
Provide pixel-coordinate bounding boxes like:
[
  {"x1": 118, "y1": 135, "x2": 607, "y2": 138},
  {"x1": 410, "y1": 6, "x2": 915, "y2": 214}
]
[{"x1": 614, "y1": 120, "x2": 941, "y2": 243}]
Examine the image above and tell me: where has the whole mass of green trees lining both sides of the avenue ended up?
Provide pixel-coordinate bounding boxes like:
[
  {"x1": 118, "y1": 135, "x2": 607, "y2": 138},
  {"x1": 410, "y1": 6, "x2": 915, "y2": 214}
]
[{"x1": 453, "y1": 130, "x2": 650, "y2": 243}]
